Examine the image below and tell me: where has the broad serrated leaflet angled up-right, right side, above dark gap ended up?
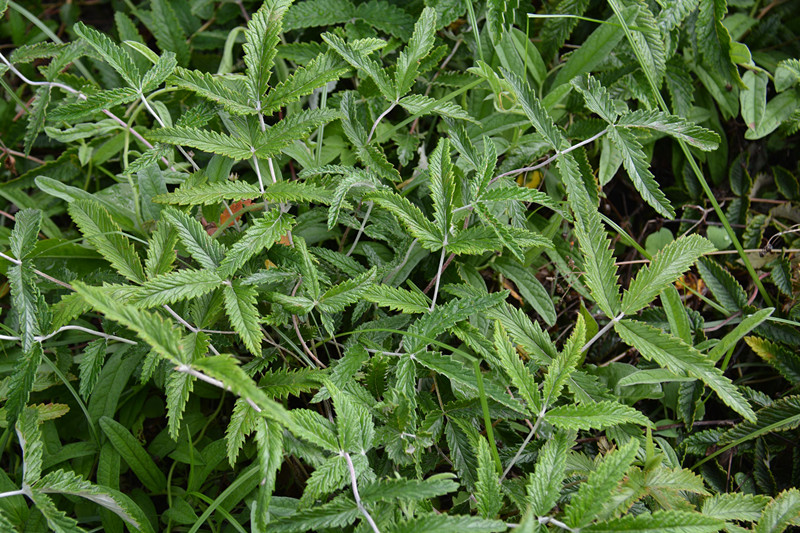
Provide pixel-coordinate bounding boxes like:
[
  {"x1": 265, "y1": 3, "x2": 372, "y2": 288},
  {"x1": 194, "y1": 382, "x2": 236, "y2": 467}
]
[{"x1": 622, "y1": 235, "x2": 715, "y2": 315}]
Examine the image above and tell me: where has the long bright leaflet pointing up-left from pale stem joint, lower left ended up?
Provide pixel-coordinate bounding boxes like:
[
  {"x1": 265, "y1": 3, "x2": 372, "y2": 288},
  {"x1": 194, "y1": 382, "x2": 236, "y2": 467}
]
[{"x1": 73, "y1": 281, "x2": 184, "y2": 364}]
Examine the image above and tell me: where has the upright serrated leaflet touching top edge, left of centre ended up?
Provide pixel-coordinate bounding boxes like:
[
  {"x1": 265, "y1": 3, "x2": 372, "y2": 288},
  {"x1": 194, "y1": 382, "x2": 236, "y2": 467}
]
[{"x1": 244, "y1": 0, "x2": 291, "y2": 101}]
